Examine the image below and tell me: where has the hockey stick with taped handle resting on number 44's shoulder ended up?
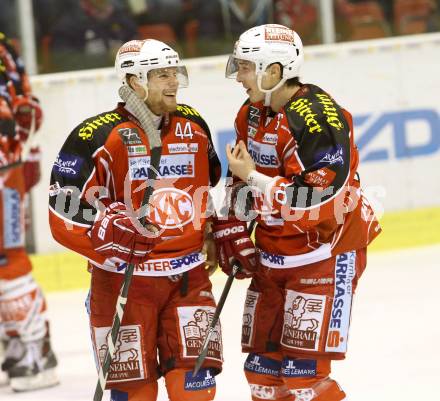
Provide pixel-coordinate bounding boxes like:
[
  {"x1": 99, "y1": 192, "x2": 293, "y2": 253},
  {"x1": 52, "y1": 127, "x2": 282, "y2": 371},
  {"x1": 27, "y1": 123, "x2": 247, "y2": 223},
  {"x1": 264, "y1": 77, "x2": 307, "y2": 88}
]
[{"x1": 93, "y1": 85, "x2": 162, "y2": 401}]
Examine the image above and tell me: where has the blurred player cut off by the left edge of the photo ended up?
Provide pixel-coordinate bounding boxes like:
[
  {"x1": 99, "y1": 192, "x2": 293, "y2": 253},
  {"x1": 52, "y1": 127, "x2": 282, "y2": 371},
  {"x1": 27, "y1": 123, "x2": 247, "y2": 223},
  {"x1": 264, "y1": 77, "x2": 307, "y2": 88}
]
[{"x1": 0, "y1": 33, "x2": 58, "y2": 391}]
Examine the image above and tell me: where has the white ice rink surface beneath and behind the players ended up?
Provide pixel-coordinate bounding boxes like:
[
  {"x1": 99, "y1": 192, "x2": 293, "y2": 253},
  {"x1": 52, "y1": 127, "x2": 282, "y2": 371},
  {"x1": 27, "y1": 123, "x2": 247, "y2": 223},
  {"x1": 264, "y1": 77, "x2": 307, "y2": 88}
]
[{"x1": 0, "y1": 245, "x2": 440, "y2": 401}]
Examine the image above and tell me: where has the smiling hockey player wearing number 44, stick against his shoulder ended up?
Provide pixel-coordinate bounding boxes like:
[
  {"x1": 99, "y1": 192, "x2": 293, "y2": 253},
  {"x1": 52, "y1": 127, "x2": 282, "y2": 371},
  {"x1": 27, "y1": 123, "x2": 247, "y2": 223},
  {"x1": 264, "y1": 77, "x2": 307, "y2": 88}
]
[{"x1": 49, "y1": 40, "x2": 222, "y2": 401}]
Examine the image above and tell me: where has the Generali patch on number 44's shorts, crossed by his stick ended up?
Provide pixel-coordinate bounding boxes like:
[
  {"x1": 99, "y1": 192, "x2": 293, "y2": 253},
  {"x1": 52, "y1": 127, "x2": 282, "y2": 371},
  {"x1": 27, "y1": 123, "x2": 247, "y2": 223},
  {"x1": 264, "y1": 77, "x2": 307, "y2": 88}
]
[{"x1": 93, "y1": 325, "x2": 147, "y2": 383}]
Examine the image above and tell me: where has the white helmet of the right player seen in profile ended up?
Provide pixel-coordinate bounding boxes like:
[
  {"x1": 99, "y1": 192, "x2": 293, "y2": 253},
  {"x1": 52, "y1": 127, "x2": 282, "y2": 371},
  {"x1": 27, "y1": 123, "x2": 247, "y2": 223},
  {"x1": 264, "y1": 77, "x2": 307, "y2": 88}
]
[{"x1": 225, "y1": 24, "x2": 304, "y2": 93}]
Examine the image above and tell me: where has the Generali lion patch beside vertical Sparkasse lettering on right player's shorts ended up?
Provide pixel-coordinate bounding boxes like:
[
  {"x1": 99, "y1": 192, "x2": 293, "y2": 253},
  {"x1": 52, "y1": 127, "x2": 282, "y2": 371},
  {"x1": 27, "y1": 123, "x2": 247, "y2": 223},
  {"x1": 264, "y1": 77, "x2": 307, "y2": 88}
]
[{"x1": 281, "y1": 290, "x2": 326, "y2": 351}]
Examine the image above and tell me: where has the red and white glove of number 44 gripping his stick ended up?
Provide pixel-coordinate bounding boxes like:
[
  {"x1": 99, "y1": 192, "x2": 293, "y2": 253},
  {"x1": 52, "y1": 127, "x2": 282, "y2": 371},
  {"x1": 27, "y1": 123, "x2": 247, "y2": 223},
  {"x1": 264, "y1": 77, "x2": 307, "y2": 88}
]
[{"x1": 90, "y1": 201, "x2": 162, "y2": 264}]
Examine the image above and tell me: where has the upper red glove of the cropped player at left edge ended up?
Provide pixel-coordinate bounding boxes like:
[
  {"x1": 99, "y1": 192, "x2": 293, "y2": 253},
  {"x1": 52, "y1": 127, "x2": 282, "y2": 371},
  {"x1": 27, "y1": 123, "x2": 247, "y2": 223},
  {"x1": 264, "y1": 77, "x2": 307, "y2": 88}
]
[{"x1": 12, "y1": 96, "x2": 43, "y2": 141}]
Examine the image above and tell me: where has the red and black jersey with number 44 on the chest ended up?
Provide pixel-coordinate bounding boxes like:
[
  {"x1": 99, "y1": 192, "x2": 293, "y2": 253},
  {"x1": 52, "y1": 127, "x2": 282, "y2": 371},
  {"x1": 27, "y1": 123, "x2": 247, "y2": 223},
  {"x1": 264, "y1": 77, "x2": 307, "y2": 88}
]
[{"x1": 49, "y1": 103, "x2": 221, "y2": 276}]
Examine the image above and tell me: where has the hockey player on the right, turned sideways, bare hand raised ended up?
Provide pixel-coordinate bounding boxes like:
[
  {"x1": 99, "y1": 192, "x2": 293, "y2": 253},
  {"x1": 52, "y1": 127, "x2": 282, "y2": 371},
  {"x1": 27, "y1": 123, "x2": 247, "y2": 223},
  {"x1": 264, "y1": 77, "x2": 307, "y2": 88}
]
[{"x1": 214, "y1": 25, "x2": 380, "y2": 401}]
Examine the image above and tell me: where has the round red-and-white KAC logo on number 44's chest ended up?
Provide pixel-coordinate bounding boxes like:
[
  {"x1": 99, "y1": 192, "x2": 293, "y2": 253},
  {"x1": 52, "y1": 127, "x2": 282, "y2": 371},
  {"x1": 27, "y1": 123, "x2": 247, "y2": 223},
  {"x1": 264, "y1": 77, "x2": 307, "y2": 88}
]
[{"x1": 149, "y1": 188, "x2": 194, "y2": 229}]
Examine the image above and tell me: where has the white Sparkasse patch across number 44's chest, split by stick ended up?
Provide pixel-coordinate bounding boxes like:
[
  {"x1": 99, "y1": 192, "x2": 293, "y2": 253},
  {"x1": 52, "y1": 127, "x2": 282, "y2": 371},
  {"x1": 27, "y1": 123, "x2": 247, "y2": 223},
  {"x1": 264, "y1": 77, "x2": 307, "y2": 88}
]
[{"x1": 128, "y1": 154, "x2": 194, "y2": 181}]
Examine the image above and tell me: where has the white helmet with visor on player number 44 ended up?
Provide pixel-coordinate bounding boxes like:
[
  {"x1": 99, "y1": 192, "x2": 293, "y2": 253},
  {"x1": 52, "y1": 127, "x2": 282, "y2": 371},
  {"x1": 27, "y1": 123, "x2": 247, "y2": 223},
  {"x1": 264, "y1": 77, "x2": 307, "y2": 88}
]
[{"x1": 115, "y1": 39, "x2": 188, "y2": 88}]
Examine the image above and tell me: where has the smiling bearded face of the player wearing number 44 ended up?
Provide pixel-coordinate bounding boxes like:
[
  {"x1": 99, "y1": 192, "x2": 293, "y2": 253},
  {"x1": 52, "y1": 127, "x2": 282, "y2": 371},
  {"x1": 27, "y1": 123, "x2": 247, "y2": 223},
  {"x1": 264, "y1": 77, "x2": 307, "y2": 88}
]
[{"x1": 147, "y1": 67, "x2": 179, "y2": 115}]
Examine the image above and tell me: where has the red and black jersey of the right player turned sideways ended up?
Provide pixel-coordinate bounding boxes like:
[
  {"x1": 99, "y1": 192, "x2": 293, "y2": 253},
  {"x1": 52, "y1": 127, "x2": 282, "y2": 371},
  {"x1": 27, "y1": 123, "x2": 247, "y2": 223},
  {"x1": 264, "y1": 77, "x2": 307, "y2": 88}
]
[{"x1": 235, "y1": 84, "x2": 380, "y2": 268}]
